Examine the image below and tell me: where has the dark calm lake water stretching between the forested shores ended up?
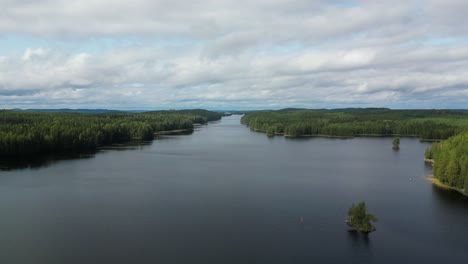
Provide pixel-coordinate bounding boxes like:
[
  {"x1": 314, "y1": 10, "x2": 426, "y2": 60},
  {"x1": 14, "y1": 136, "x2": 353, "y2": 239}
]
[{"x1": 0, "y1": 116, "x2": 468, "y2": 264}]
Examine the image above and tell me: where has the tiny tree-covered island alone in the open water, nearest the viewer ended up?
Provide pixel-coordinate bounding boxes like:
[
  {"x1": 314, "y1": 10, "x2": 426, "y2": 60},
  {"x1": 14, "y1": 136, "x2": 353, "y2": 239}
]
[{"x1": 345, "y1": 202, "x2": 377, "y2": 233}]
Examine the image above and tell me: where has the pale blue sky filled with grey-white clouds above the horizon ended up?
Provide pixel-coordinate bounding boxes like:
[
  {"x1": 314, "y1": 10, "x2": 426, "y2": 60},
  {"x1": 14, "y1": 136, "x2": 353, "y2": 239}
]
[{"x1": 0, "y1": 0, "x2": 468, "y2": 110}]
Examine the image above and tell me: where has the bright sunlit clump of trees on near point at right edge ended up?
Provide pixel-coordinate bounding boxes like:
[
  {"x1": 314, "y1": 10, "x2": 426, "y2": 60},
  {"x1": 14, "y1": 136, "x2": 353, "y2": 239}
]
[{"x1": 425, "y1": 131, "x2": 468, "y2": 194}]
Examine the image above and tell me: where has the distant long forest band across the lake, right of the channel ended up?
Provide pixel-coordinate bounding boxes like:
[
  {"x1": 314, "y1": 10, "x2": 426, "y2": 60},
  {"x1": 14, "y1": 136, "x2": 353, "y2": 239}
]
[{"x1": 241, "y1": 108, "x2": 468, "y2": 140}]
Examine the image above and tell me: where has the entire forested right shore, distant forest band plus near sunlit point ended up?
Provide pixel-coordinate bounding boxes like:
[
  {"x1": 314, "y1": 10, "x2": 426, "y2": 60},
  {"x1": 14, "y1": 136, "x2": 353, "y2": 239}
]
[{"x1": 241, "y1": 108, "x2": 468, "y2": 195}]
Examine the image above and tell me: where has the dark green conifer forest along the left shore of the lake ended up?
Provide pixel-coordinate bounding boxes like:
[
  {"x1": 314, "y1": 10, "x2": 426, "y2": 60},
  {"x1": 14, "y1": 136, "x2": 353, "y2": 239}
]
[{"x1": 0, "y1": 109, "x2": 221, "y2": 157}]
